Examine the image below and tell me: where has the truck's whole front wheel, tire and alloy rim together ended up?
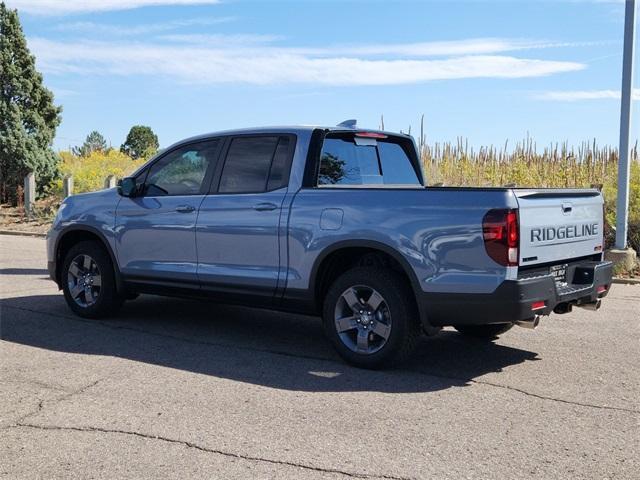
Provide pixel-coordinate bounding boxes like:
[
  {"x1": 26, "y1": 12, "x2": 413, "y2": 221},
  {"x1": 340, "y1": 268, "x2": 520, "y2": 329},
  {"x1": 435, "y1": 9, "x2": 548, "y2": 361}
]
[{"x1": 61, "y1": 241, "x2": 124, "y2": 318}]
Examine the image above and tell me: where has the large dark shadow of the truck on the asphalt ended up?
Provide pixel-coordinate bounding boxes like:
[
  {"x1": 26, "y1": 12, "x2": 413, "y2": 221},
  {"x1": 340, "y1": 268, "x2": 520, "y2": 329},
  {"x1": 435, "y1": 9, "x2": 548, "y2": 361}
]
[{"x1": 0, "y1": 294, "x2": 537, "y2": 393}]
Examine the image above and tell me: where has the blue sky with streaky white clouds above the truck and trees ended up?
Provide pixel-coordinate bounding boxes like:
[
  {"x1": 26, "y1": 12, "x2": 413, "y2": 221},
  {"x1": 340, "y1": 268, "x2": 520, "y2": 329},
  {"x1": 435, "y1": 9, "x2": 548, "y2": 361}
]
[{"x1": 6, "y1": 0, "x2": 640, "y2": 149}]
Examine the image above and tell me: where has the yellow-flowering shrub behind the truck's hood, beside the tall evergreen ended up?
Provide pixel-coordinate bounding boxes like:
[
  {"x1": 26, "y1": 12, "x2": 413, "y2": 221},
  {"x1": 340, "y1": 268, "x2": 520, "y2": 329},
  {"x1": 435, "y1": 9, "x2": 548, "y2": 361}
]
[{"x1": 55, "y1": 150, "x2": 145, "y2": 193}]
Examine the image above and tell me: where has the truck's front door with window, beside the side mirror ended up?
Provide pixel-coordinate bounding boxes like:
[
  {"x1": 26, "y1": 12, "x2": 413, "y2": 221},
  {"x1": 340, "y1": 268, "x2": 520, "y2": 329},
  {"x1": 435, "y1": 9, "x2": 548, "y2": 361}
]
[{"x1": 115, "y1": 139, "x2": 220, "y2": 287}]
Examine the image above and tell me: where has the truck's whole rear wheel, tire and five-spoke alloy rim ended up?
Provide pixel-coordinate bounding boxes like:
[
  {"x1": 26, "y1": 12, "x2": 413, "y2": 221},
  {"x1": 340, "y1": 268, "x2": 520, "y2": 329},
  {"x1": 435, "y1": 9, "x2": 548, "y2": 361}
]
[{"x1": 323, "y1": 267, "x2": 420, "y2": 369}]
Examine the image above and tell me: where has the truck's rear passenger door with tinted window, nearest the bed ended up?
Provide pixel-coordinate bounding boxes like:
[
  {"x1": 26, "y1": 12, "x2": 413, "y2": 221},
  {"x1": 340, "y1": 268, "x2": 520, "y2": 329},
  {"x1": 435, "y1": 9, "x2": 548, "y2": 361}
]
[{"x1": 196, "y1": 134, "x2": 295, "y2": 300}]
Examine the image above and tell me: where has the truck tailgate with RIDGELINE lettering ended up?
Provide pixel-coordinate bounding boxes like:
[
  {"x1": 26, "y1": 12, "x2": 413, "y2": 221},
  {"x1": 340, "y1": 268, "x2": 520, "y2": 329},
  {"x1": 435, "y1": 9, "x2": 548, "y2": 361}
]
[{"x1": 514, "y1": 189, "x2": 604, "y2": 267}]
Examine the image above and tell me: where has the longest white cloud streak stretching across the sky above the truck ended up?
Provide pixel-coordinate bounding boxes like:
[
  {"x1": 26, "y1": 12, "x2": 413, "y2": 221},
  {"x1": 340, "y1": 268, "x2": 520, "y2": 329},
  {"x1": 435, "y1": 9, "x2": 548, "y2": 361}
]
[{"x1": 29, "y1": 38, "x2": 585, "y2": 85}]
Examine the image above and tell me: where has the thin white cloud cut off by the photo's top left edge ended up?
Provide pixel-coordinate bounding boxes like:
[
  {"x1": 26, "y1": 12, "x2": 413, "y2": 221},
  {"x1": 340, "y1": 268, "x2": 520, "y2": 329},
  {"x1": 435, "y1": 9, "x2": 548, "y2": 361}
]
[{"x1": 6, "y1": 0, "x2": 220, "y2": 15}]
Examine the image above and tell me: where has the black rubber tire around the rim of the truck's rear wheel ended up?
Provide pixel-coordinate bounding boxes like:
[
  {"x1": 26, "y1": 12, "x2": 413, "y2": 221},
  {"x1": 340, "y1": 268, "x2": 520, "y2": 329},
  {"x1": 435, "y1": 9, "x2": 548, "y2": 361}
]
[{"x1": 322, "y1": 267, "x2": 421, "y2": 369}]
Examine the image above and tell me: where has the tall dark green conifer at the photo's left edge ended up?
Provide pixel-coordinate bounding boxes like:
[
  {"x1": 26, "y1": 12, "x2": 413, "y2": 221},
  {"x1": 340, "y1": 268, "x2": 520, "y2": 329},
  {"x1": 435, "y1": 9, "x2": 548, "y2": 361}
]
[{"x1": 0, "y1": 2, "x2": 62, "y2": 204}]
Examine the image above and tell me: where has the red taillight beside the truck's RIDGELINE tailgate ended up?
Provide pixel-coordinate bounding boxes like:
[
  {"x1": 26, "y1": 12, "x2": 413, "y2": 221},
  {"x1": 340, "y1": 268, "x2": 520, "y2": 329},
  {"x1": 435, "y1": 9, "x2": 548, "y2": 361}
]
[{"x1": 482, "y1": 209, "x2": 519, "y2": 267}]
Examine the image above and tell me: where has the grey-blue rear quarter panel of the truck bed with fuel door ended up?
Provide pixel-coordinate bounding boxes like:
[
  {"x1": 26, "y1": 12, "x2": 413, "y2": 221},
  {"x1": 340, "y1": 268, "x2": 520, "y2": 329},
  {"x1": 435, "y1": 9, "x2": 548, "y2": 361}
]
[{"x1": 286, "y1": 188, "x2": 517, "y2": 293}]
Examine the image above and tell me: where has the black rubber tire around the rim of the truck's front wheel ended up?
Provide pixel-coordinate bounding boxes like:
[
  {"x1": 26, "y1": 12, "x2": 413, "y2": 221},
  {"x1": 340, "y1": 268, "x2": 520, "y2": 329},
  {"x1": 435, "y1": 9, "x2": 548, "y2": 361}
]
[{"x1": 60, "y1": 241, "x2": 124, "y2": 318}]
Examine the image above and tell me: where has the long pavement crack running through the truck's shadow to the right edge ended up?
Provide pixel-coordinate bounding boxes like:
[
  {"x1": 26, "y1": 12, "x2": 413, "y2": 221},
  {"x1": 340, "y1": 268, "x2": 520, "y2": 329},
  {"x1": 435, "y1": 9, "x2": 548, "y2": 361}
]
[{"x1": 5, "y1": 305, "x2": 640, "y2": 414}]
